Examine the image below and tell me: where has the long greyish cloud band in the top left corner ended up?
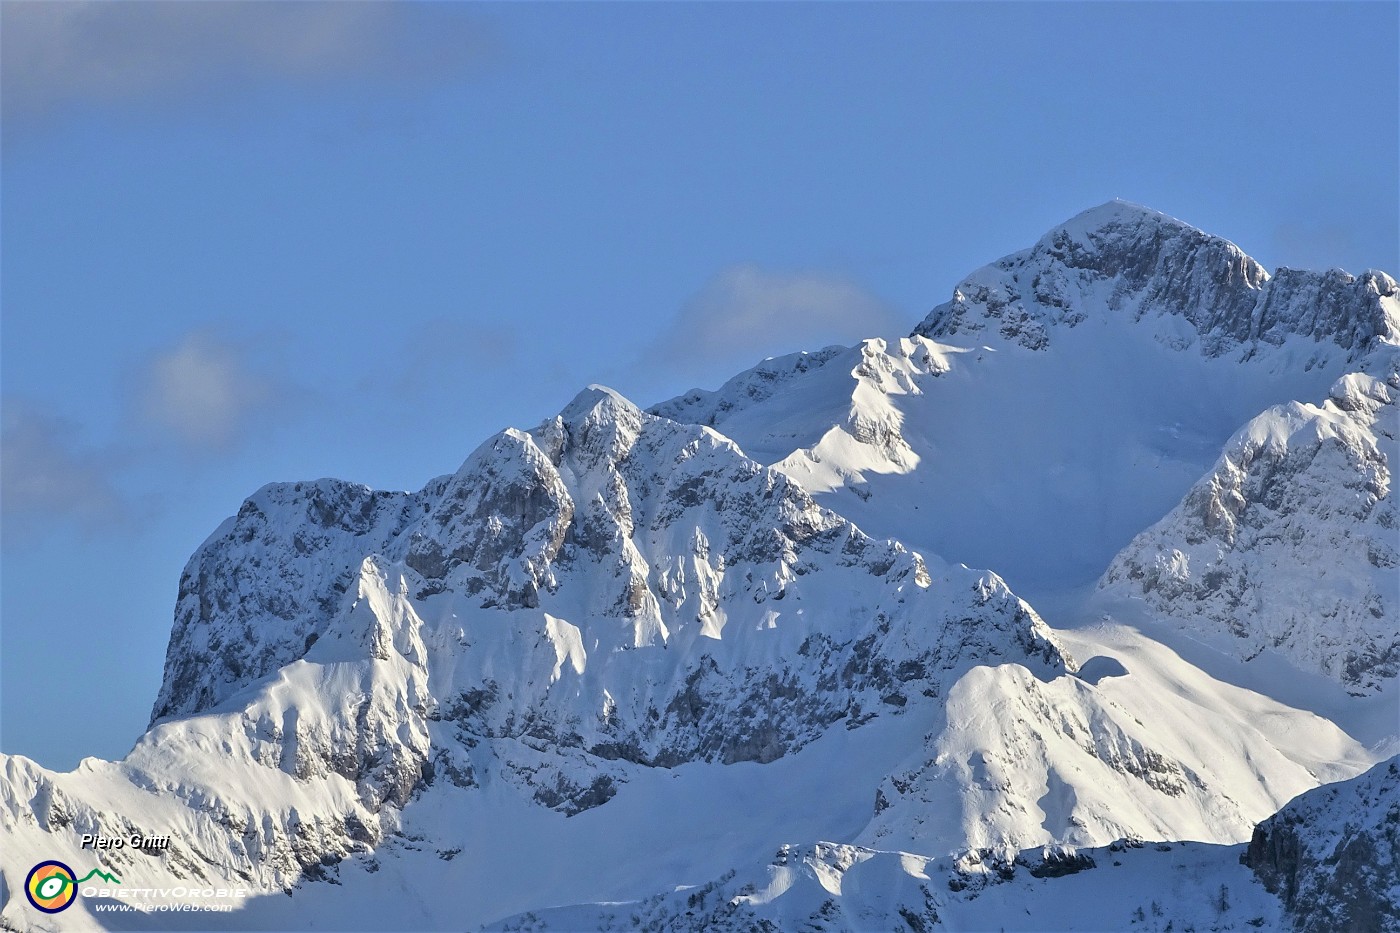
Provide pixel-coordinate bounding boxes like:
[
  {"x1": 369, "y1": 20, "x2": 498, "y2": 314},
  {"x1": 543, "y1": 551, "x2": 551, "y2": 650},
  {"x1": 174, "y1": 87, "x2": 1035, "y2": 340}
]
[{"x1": 0, "y1": 0, "x2": 490, "y2": 120}]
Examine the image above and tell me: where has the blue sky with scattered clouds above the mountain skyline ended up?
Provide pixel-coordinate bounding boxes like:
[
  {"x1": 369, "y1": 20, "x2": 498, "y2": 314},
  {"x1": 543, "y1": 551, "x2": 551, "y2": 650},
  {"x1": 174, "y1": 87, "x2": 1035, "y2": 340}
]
[{"x1": 0, "y1": 1, "x2": 1400, "y2": 769}]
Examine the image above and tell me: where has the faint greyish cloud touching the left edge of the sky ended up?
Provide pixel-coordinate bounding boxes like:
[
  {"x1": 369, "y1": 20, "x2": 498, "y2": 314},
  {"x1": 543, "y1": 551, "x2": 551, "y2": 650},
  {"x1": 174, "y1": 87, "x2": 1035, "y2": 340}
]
[{"x1": 0, "y1": 399, "x2": 130, "y2": 545}]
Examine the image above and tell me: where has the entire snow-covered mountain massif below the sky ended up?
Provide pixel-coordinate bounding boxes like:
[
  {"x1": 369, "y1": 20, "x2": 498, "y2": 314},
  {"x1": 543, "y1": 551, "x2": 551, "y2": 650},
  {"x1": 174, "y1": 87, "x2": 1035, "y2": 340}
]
[{"x1": 0, "y1": 202, "x2": 1400, "y2": 929}]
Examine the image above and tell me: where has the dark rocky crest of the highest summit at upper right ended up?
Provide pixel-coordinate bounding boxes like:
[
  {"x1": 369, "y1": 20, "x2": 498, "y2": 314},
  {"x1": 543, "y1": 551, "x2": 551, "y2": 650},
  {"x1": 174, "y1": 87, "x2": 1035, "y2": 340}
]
[{"x1": 916, "y1": 202, "x2": 1400, "y2": 360}]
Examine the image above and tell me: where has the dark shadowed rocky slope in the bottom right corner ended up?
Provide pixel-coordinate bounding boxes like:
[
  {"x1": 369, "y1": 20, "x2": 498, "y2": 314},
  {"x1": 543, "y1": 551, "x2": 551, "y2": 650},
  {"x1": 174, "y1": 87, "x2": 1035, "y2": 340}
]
[{"x1": 1242, "y1": 758, "x2": 1400, "y2": 933}]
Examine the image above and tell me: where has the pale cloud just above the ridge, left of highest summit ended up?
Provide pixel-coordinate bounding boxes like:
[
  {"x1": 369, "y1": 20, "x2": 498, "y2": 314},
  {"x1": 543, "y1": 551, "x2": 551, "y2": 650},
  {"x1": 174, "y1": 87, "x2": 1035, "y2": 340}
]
[{"x1": 654, "y1": 265, "x2": 909, "y2": 373}]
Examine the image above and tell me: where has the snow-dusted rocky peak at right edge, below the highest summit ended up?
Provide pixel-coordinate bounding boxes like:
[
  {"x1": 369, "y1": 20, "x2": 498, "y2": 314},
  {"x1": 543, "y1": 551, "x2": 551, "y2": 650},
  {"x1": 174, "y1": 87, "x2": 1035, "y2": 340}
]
[{"x1": 1099, "y1": 373, "x2": 1400, "y2": 692}]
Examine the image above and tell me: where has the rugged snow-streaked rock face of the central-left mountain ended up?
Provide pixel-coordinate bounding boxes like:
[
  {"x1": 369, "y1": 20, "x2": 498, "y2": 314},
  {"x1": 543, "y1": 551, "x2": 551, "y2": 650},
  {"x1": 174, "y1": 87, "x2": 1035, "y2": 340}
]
[{"x1": 157, "y1": 389, "x2": 1067, "y2": 765}]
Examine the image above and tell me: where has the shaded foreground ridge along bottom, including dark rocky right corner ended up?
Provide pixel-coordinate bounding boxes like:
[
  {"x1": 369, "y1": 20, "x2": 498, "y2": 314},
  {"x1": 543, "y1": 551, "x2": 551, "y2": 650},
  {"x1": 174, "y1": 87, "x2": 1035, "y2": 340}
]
[{"x1": 491, "y1": 759, "x2": 1400, "y2": 933}]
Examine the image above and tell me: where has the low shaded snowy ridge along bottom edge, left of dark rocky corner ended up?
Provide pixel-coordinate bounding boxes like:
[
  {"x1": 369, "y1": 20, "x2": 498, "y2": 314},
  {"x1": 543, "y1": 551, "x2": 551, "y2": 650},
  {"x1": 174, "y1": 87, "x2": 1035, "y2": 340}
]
[{"x1": 487, "y1": 842, "x2": 1288, "y2": 933}]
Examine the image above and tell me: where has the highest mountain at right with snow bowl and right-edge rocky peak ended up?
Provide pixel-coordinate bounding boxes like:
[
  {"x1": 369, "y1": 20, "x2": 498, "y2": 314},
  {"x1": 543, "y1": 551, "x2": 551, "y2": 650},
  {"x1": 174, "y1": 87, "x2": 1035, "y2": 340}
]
[{"x1": 654, "y1": 202, "x2": 1400, "y2": 692}]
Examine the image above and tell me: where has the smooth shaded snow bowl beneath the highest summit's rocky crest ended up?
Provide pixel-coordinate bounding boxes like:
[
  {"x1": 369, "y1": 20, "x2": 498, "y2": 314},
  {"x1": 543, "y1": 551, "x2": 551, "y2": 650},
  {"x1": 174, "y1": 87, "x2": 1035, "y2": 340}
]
[{"x1": 654, "y1": 317, "x2": 1372, "y2": 597}]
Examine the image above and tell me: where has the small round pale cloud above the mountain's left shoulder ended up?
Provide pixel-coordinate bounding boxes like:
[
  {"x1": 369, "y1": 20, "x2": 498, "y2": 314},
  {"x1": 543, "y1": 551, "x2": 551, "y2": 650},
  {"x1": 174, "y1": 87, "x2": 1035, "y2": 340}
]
[{"x1": 137, "y1": 333, "x2": 279, "y2": 451}]
